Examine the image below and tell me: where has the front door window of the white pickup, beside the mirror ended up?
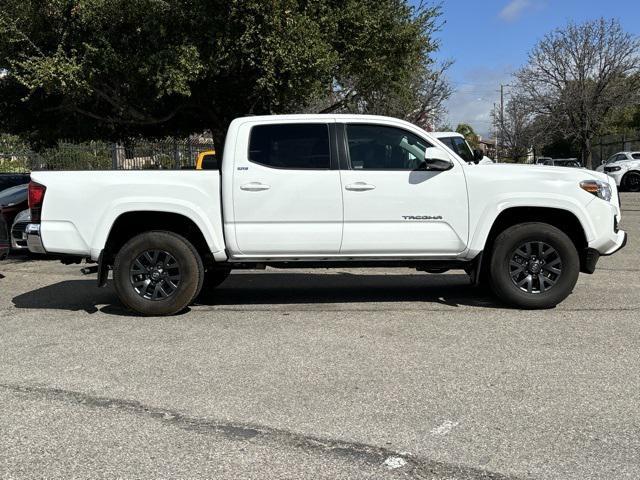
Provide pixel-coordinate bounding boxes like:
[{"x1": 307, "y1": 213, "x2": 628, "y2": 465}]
[{"x1": 347, "y1": 124, "x2": 431, "y2": 170}]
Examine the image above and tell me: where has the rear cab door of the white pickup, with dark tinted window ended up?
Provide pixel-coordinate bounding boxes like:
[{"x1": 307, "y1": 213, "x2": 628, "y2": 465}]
[{"x1": 233, "y1": 121, "x2": 343, "y2": 257}]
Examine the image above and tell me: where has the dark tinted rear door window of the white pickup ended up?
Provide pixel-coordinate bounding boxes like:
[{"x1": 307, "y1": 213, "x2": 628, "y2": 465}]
[{"x1": 249, "y1": 123, "x2": 331, "y2": 169}]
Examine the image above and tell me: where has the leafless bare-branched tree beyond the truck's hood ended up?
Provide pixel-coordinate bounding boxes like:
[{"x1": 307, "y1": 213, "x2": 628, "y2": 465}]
[{"x1": 516, "y1": 19, "x2": 640, "y2": 168}]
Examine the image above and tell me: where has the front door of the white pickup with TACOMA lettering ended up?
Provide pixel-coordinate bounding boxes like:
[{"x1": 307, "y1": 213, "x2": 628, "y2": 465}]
[{"x1": 338, "y1": 123, "x2": 469, "y2": 257}]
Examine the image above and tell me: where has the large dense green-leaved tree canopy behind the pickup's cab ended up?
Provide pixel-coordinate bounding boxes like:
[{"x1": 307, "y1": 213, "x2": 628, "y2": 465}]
[{"x1": 0, "y1": 0, "x2": 450, "y2": 147}]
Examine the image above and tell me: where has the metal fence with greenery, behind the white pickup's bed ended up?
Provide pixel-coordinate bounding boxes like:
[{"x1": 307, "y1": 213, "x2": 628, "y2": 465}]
[{"x1": 0, "y1": 138, "x2": 214, "y2": 172}]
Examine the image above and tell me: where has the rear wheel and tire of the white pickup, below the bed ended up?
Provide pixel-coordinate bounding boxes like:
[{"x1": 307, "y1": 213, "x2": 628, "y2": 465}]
[{"x1": 113, "y1": 231, "x2": 204, "y2": 316}]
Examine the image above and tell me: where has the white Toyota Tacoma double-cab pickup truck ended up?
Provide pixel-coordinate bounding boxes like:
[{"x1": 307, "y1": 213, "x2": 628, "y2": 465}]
[{"x1": 27, "y1": 115, "x2": 626, "y2": 315}]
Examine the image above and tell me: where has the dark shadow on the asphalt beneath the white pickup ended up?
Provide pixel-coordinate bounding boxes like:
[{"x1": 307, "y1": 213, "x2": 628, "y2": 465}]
[{"x1": 8, "y1": 272, "x2": 503, "y2": 315}]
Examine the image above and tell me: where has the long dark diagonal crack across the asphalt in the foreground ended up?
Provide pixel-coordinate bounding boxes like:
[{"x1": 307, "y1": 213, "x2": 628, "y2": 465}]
[{"x1": 0, "y1": 383, "x2": 520, "y2": 480}]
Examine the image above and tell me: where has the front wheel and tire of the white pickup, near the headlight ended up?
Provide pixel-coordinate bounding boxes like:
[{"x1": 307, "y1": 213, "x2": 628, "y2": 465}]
[{"x1": 489, "y1": 223, "x2": 580, "y2": 309}]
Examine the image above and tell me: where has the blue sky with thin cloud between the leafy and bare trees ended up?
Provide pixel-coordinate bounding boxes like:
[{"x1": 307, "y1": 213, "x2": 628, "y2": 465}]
[{"x1": 420, "y1": 0, "x2": 640, "y2": 137}]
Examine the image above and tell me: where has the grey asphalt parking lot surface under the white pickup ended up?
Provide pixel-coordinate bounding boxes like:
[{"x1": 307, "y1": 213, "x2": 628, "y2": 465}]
[{"x1": 0, "y1": 194, "x2": 640, "y2": 479}]
